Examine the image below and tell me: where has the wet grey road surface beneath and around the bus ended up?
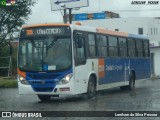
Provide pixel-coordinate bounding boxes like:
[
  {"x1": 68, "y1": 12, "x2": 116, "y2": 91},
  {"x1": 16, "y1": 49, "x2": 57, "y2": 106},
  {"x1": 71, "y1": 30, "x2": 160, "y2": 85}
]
[{"x1": 0, "y1": 79, "x2": 160, "y2": 120}]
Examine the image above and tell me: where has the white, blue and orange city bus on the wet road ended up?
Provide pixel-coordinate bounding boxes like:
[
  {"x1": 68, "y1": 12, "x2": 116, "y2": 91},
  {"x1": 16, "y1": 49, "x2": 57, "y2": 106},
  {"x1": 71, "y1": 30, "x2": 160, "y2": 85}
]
[{"x1": 18, "y1": 24, "x2": 150, "y2": 101}]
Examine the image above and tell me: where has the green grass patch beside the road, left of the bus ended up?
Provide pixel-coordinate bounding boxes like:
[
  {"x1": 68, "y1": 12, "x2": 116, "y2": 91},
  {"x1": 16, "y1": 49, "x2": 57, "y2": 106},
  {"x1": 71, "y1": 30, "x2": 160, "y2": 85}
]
[{"x1": 0, "y1": 78, "x2": 18, "y2": 88}]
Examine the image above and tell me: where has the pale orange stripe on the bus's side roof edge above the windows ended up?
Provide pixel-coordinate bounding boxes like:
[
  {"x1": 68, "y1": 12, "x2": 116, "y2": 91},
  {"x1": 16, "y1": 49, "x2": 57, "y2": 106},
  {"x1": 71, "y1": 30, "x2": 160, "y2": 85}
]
[{"x1": 96, "y1": 28, "x2": 128, "y2": 37}]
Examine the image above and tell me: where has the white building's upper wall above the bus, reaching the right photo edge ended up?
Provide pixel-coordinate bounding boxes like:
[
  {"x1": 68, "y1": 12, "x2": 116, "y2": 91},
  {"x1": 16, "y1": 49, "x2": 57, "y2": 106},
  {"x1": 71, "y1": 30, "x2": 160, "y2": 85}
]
[{"x1": 75, "y1": 17, "x2": 160, "y2": 41}]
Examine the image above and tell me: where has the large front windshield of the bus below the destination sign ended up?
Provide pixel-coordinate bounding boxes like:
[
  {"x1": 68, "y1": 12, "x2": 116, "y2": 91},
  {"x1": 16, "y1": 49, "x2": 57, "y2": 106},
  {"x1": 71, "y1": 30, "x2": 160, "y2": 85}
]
[{"x1": 19, "y1": 36, "x2": 72, "y2": 71}]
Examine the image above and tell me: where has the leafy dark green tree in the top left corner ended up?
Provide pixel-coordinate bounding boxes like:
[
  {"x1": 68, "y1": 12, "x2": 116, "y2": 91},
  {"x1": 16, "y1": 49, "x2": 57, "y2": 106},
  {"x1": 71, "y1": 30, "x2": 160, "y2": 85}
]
[{"x1": 0, "y1": 0, "x2": 35, "y2": 45}]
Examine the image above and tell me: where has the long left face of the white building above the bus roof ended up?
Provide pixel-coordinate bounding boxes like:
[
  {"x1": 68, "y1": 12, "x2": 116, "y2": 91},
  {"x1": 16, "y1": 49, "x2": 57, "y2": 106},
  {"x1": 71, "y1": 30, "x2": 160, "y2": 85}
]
[{"x1": 77, "y1": 18, "x2": 151, "y2": 35}]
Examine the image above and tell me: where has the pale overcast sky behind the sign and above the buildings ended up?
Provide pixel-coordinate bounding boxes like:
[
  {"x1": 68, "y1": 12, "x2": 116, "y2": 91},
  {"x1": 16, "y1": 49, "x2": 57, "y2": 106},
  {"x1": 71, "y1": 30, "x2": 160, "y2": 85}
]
[{"x1": 27, "y1": 0, "x2": 160, "y2": 24}]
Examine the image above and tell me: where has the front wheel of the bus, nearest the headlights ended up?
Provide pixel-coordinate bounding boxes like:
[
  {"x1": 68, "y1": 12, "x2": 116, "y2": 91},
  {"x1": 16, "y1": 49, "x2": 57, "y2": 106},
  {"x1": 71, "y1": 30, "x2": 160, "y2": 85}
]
[{"x1": 87, "y1": 76, "x2": 96, "y2": 98}]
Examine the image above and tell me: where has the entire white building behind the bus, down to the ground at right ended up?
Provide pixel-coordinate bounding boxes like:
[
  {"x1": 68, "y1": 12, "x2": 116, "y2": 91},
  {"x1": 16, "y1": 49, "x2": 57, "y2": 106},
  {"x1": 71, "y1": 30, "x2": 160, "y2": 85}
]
[{"x1": 75, "y1": 17, "x2": 160, "y2": 77}]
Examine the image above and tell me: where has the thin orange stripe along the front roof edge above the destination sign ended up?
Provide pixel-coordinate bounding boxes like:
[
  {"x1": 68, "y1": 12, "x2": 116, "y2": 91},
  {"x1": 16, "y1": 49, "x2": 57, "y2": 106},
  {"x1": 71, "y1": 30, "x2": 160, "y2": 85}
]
[{"x1": 22, "y1": 24, "x2": 69, "y2": 28}]
